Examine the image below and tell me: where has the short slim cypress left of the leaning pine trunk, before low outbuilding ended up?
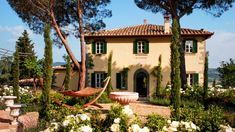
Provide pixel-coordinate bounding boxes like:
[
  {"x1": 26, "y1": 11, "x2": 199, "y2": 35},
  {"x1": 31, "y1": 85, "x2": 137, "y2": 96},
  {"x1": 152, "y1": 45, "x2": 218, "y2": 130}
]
[{"x1": 64, "y1": 55, "x2": 71, "y2": 90}]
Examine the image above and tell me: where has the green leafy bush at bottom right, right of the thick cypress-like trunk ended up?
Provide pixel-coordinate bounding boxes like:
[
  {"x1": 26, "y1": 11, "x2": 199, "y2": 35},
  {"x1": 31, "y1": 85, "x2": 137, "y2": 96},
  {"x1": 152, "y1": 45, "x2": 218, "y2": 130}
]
[{"x1": 180, "y1": 105, "x2": 225, "y2": 131}]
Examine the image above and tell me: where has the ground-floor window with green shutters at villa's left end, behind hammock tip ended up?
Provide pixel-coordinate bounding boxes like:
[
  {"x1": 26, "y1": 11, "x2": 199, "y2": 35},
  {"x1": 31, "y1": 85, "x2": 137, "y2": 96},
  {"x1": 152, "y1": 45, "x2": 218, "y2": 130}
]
[{"x1": 91, "y1": 72, "x2": 107, "y2": 88}]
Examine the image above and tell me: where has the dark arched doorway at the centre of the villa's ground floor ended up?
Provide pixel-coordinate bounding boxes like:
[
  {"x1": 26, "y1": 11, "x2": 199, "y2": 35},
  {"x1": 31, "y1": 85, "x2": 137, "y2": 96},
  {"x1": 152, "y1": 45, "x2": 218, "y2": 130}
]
[{"x1": 134, "y1": 69, "x2": 149, "y2": 97}]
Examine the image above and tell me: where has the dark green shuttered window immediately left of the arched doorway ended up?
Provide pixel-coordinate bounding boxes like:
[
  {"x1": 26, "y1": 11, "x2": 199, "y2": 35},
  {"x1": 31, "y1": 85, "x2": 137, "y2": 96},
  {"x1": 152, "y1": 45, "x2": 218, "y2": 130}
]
[{"x1": 116, "y1": 71, "x2": 128, "y2": 89}]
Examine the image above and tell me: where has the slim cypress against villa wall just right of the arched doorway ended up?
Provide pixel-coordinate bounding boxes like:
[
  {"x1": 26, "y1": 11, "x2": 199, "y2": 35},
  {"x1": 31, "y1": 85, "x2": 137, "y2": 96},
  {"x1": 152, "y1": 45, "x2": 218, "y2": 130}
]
[{"x1": 156, "y1": 55, "x2": 162, "y2": 96}]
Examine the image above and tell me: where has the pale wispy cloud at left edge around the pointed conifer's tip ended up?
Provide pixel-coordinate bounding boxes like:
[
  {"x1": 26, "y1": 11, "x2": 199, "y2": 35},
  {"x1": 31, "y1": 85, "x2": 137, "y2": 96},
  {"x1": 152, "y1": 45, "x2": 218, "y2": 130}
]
[{"x1": 0, "y1": 25, "x2": 33, "y2": 42}]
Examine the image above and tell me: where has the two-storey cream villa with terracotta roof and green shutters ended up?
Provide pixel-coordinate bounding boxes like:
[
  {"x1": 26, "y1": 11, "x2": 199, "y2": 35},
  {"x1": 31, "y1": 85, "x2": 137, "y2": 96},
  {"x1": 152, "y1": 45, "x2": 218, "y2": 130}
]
[{"x1": 85, "y1": 16, "x2": 213, "y2": 97}]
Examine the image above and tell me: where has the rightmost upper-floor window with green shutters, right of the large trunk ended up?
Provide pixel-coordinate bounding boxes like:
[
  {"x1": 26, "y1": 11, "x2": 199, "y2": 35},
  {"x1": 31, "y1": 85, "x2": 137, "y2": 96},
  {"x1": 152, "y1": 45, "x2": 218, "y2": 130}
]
[{"x1": 183, "y1": 39, "x2": 197, "y2": 53}]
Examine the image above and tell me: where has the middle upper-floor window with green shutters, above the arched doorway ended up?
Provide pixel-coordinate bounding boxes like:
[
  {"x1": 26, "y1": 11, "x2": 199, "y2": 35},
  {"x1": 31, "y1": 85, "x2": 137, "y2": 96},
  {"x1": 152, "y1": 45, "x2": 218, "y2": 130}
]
[{"x1": 133, "y1": 40, "x2": 149, "y2": 54}]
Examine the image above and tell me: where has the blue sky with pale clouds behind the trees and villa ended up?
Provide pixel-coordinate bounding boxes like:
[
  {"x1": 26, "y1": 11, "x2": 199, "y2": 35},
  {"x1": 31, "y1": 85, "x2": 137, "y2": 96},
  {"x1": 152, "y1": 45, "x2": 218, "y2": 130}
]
[{"x1": 0, "y1": 0, "x2": 235, "y2": 68}]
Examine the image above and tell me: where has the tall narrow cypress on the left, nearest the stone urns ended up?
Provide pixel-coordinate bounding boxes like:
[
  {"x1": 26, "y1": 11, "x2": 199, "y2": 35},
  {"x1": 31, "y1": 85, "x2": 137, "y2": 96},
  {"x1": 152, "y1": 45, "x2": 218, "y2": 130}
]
[{"x1": 40, "y1": 24, "x2": 53, "y2": 121}]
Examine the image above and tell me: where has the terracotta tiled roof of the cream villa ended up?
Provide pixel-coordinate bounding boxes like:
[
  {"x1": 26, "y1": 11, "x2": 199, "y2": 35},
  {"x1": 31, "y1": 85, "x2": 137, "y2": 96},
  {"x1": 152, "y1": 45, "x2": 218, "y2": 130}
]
[{"x1": 85, "y1": 24, "x2": 213, "y2": 37}]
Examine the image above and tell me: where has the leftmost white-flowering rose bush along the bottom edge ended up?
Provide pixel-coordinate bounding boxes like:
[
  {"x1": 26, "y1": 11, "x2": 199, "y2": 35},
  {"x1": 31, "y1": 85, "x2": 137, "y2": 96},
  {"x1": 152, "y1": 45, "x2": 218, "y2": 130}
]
[{"x1": 44, "y1": 114, "x2": 92, "y2": 132}]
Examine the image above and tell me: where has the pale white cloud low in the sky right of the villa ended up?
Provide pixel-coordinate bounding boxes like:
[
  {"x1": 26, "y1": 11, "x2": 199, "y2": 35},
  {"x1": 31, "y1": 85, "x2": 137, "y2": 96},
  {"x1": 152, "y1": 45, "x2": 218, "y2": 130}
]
[{"x1": 207, "y1": 31, "x2": 235, "y2": 67}]
